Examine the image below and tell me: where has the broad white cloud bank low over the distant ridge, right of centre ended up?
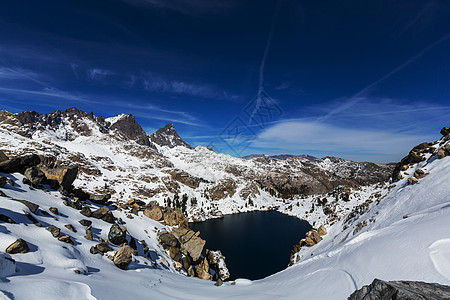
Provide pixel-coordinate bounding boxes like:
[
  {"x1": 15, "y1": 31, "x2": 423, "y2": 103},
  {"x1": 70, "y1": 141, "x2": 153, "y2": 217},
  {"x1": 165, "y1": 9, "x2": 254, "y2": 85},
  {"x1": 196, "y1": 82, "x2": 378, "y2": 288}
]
[{"x1": 252, "y1": 120, "x2": 427, "y2": 162}]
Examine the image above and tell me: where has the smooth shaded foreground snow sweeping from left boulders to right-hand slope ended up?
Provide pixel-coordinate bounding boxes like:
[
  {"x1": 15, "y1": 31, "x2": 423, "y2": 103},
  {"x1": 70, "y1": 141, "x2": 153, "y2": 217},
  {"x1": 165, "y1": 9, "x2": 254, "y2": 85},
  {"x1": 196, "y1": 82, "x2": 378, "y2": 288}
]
[{"x1": 0, "y1": 127, "x2": 450, "y2": 299}]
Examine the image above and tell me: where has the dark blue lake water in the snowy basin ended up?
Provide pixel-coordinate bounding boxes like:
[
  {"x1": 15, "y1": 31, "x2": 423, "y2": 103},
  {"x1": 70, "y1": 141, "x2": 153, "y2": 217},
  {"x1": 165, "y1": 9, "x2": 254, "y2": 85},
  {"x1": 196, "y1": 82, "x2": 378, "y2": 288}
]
[{"x1": 189, "y1": 211, "x2": 312, "y2": 280}]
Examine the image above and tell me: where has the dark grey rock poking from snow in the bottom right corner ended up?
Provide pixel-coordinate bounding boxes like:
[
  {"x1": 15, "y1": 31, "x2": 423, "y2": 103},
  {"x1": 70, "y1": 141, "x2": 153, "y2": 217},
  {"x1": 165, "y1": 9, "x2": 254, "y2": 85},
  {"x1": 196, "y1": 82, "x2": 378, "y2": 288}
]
[{"x1": 348, "y1": 279, "x2": 450, "y2": 300}]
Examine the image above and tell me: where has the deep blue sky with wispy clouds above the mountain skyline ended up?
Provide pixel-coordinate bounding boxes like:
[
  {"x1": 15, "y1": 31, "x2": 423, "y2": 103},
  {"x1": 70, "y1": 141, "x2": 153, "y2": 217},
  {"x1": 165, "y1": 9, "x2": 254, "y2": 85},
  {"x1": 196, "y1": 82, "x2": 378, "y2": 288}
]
[{"x1": 0, "y1": 0, "x2": 450, "y2": 162}]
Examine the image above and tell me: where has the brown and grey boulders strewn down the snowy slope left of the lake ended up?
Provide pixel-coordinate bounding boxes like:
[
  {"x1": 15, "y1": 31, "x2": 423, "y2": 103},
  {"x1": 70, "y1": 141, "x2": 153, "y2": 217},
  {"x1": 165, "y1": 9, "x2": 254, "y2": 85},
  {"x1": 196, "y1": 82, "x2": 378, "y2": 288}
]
[{"x1": 0, "y1": 151, "x2": 230, "y2": 282}]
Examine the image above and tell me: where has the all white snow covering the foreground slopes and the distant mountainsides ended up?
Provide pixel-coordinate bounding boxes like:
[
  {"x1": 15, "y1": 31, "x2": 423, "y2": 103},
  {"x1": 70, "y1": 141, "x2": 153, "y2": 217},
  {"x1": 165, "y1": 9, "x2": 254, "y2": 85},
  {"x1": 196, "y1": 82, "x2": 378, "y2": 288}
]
[{"x1": 0, "y1": 113, "x2": 450, "y2": 299}]
